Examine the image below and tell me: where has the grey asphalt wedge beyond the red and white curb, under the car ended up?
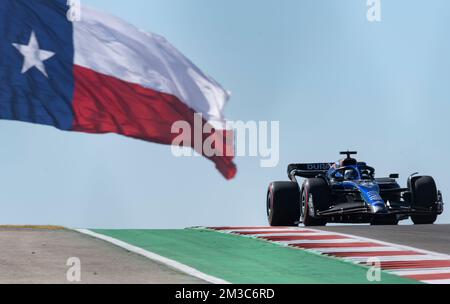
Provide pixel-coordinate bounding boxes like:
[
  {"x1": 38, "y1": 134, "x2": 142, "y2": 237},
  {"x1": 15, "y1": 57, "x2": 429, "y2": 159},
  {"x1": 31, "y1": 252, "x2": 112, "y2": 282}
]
[{"x1": 318, "y1": 225, "x2": 450, "y2": 254}]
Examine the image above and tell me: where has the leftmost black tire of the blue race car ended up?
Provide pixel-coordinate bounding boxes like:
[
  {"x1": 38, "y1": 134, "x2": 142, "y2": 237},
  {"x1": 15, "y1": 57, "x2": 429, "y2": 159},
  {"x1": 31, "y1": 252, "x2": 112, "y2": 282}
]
[{"x1": 267, "y1": 182, "x2": 300, "y2": 227}]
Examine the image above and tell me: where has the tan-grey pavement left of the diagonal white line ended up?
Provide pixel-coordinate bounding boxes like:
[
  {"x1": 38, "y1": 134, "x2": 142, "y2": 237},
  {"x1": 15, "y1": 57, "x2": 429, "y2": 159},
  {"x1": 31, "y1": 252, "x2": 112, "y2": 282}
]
[{"x1": 0, "y1": 228, "x2": 203, "y2": 284}]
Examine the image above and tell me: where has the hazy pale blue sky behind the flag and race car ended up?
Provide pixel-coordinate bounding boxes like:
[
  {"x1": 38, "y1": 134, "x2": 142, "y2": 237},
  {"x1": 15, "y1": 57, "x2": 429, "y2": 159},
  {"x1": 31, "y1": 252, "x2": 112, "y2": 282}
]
[{"x1": 0, "y1": 0, "x2": 450, "y2": 228}]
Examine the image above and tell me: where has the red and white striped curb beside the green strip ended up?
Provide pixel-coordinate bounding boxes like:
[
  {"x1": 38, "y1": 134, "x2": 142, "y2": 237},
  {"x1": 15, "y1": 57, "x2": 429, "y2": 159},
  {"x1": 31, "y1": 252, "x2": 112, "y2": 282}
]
[{"x1": 208, "y1": 227, "x2": 450, "y2": 284}]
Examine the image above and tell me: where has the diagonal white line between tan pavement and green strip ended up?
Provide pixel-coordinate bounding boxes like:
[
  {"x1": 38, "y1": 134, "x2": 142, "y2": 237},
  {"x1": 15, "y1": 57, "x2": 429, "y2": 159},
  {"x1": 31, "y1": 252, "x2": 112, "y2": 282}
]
[{"x1": 75, "y1": 229, "x2": 231, "y2": 284}]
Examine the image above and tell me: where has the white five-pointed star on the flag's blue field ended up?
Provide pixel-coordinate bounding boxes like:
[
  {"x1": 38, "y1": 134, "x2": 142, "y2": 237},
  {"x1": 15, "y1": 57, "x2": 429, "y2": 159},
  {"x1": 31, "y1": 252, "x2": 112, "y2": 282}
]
[{"x1": 12, "y1": 31, "x2": 55, "y2": 78}]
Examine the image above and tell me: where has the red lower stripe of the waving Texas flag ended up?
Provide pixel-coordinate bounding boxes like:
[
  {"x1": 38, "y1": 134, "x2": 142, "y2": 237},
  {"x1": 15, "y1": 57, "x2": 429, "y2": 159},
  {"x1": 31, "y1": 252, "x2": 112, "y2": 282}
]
[{"x1": 73, "y1": 66, "x2": 237, "y2": 179}]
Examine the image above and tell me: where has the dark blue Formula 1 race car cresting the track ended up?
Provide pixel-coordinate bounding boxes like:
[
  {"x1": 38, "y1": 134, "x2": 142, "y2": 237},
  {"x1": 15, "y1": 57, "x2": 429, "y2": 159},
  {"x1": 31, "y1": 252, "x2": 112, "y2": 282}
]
[{"x1": 267, "y1": 152, "x2": 444, "y2": 226}]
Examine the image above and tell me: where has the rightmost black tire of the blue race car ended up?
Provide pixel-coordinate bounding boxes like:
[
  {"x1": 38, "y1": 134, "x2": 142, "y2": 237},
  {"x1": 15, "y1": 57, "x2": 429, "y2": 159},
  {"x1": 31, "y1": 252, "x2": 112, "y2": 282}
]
[{"x1": 410, "y1": 176, "x2": 438, "y2": 225}]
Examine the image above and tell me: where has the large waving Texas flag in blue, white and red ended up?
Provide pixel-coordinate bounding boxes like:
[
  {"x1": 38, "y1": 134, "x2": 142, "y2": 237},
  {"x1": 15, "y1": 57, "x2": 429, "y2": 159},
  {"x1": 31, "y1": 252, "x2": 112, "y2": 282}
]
[{"x1": 0, "y1": 0, "x2": 236, "y2": 179}]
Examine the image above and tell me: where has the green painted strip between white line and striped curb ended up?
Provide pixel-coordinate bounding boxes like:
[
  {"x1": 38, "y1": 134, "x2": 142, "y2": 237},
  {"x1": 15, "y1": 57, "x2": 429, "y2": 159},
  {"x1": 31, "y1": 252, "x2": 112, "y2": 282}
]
[{"x1": 92, "y1": 229, "x2": 417, "y2": 284}]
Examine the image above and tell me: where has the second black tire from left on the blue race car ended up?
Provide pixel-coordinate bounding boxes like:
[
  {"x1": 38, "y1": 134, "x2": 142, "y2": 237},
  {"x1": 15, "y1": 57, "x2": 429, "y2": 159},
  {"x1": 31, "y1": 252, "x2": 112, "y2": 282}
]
[{"x1": 300, "y1": 178, "x2": 331, "y2": 227}]
